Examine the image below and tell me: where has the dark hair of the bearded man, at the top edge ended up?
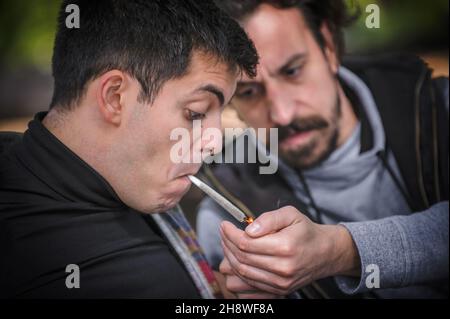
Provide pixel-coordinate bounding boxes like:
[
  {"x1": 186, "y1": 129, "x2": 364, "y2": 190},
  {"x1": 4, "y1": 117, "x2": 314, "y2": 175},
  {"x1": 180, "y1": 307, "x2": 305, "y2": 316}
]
[{"x1": 215, "y1": 0, "x2": 360, "y2": 58}]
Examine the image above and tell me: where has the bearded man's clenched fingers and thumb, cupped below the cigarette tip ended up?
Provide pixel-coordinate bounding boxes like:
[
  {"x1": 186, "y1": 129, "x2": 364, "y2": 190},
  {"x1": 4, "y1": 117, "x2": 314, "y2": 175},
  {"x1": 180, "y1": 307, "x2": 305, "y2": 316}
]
[{"x1": 220, "y1": 207, "x2": 311, "y2": 298}]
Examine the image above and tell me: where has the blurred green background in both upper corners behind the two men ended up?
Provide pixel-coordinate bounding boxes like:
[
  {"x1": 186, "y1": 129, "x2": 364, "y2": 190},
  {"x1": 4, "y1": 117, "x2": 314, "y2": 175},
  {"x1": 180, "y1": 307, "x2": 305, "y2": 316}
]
[{"x1": 0, "y1": 0, "x2": 449, "y2": 124}]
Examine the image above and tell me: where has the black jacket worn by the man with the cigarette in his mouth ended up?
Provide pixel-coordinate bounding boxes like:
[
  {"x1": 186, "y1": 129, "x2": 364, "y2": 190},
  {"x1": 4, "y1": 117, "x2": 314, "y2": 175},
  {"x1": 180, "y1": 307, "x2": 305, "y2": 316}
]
[{"x1": 0, "y1": 115, "x2": 200, "y2": 298}]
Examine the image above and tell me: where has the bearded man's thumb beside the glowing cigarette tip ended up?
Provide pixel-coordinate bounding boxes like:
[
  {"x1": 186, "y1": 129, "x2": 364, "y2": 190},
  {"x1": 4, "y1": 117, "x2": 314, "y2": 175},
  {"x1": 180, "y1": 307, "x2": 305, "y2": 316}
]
[{"x1": 245, "y1": 206, "x2": 305, "y2": 237}]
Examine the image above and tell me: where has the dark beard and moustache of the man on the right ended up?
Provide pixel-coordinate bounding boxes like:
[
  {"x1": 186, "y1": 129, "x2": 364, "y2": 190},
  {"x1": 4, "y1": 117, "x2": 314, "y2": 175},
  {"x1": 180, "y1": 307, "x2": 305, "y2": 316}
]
[{"x1": 277, "y1": 95, "x2": 342, "y2": 169}]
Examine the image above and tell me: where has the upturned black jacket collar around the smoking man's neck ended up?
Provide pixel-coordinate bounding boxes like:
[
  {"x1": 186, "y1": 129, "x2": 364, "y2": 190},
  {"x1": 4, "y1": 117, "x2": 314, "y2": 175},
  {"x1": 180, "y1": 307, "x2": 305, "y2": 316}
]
[{"x1": 17, "y1": 112, "x2": 125, "y2": 208}]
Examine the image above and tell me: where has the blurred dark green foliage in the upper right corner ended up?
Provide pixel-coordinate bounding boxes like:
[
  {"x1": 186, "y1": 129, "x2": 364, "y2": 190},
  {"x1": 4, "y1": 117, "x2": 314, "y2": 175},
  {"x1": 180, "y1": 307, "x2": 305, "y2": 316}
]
[{"x1": 346, "y1": 0, "x2": 449, "y2": 52}]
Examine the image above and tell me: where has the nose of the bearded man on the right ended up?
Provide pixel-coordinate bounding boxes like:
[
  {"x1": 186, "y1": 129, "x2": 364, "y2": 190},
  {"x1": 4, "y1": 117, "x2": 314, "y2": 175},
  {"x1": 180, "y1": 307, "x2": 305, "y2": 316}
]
[{"x1": 268, "y1": 90, "x2": 295, "y2": 126}]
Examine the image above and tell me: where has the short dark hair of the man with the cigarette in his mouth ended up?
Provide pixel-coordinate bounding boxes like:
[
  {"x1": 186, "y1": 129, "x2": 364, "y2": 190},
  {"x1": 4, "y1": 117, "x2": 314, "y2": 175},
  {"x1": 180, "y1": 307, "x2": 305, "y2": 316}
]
[{"x1": 50, "y1": 0, "x2": 258, "y2": 109}]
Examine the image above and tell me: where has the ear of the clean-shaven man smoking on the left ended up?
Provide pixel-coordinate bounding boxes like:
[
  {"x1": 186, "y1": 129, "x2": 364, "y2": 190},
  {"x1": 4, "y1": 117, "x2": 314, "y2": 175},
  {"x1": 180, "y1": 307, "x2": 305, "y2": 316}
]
[{"x1": 97, "y1": 70, "x2": 129, "y2": 125}]
